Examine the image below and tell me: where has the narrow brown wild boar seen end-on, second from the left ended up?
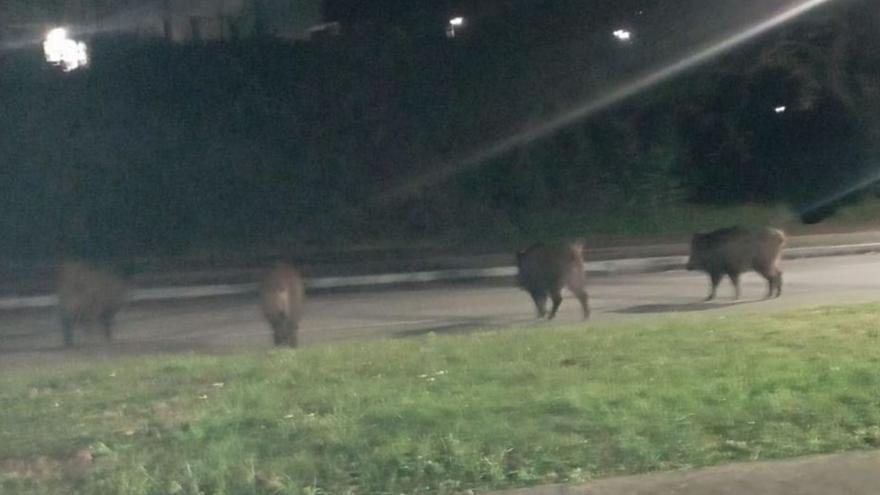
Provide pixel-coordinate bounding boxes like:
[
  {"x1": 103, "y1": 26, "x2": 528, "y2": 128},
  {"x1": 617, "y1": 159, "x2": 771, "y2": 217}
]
[{"x1": 260, "y1": 263, "x2": 305, "y2": 347}]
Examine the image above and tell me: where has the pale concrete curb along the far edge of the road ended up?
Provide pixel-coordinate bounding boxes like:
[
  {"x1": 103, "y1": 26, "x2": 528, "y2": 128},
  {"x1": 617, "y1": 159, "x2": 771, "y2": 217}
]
[{"x1": 0, "y1": 243, "x2": 880, "y2": 311}]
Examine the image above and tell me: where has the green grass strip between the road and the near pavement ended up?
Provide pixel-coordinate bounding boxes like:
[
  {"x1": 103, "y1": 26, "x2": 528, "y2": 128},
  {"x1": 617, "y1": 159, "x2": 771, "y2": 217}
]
[{"x1": 0, "y1": 304, "x2": 880, "y2": 495}]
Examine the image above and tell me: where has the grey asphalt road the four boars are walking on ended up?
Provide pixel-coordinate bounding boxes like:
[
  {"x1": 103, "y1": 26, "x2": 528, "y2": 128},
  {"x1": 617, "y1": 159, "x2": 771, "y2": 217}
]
[{"x1": 0, "y1": 255, "x2": 880, "y2": 369}]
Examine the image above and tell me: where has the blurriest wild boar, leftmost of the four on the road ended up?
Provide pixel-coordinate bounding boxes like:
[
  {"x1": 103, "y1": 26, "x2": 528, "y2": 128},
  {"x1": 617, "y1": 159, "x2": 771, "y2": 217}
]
[{"x1": 58, "y1": 261, "x2": 128, "y2": 347}]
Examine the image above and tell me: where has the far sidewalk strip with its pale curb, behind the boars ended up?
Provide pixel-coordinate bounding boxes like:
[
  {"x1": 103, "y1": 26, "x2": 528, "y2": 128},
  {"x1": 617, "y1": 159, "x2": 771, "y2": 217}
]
[{"x1": 0, "y1": 231, "x2": 880, "y2": 310}]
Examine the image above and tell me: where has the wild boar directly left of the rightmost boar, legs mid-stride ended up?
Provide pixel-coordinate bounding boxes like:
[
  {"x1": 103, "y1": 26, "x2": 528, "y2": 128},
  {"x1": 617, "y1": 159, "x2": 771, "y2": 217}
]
[{"x1": 516, "y1": 243, "x2": 590, "y2": 320}]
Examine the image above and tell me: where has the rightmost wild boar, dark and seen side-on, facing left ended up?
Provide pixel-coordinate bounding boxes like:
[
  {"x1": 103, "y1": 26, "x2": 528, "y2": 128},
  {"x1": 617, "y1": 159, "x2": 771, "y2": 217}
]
[{"x1": 687, "y1": 226, "x2": 785, "y2": 301}]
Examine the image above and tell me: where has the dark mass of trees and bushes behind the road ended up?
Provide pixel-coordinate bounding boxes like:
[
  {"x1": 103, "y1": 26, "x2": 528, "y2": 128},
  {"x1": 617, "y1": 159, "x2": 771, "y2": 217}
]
[{"x1": 0, "y1": 1, "x2": 880, "y2": 259}]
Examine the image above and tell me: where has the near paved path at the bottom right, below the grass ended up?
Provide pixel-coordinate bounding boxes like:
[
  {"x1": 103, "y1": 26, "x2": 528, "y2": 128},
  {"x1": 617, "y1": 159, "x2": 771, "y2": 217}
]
[{"x1": 486, "y1": 451, "x2": 880, "y2": 495}]
